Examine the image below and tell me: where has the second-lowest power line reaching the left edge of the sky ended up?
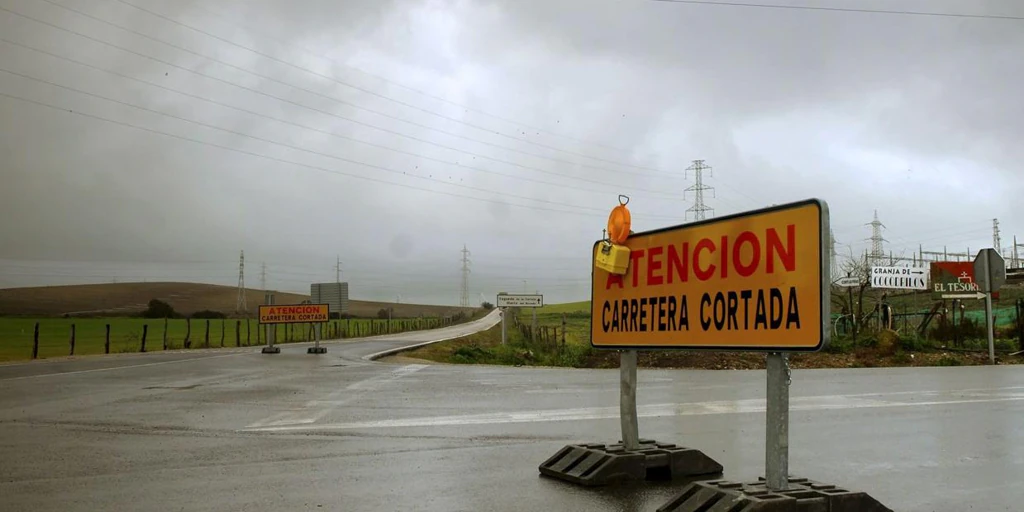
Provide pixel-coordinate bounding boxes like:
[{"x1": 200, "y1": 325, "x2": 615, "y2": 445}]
[{"x1": 0, "y1": 68, "x2": 679, "y2": 217}]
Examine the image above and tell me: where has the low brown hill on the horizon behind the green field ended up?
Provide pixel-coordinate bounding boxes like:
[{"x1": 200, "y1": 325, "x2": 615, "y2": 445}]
[{"x1": 0, "y1": 283, "x2": 472, "y2": 317}]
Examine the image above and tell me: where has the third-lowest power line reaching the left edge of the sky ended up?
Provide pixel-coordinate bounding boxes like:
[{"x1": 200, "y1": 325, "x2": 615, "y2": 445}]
[{"x1": 0, "y1": 36, "x2": 684, "y2": 200}]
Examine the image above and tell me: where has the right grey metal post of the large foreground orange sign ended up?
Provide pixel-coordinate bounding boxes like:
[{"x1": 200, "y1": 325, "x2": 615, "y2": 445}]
[{"x1": 765, "y1": 352, "x2": 790, "y2": 492}]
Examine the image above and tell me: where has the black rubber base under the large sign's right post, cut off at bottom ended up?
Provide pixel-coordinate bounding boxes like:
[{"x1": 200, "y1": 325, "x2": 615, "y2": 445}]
[{"x1": 657, "y1": 478, "x2": 893, "y2": 512}]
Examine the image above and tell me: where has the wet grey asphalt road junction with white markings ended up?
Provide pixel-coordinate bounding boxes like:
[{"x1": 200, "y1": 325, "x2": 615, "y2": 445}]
[{"x1": 0, "y1": 307, "x2": 1024, "y2": 512}]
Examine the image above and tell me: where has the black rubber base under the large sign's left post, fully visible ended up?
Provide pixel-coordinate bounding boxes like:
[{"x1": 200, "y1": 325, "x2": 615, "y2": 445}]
[{"x1": 540, "y1": 439, "x2": 722, "y2": 486}]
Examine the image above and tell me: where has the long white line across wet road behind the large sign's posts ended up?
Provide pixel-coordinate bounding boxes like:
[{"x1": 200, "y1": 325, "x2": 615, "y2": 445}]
[{"x1": 241, "y1": 393, "x2": 1024, "y2": 432}]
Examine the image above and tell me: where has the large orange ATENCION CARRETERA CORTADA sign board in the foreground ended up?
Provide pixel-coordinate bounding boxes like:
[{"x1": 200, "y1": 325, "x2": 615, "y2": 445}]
[{"x1": 591, "y1": 200, "x2": 829, "y2": 351}]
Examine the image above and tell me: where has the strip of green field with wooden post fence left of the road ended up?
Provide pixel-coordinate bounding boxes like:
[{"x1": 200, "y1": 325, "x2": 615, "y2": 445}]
[{"x1": 6, "y1": 312, "x2": 470, "y2": 360}]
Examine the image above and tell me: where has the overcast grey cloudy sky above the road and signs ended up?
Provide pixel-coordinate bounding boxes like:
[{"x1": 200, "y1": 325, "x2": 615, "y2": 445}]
[{"x1": 0, "y1": 0, "x2": 1024, "y2": 303}]
